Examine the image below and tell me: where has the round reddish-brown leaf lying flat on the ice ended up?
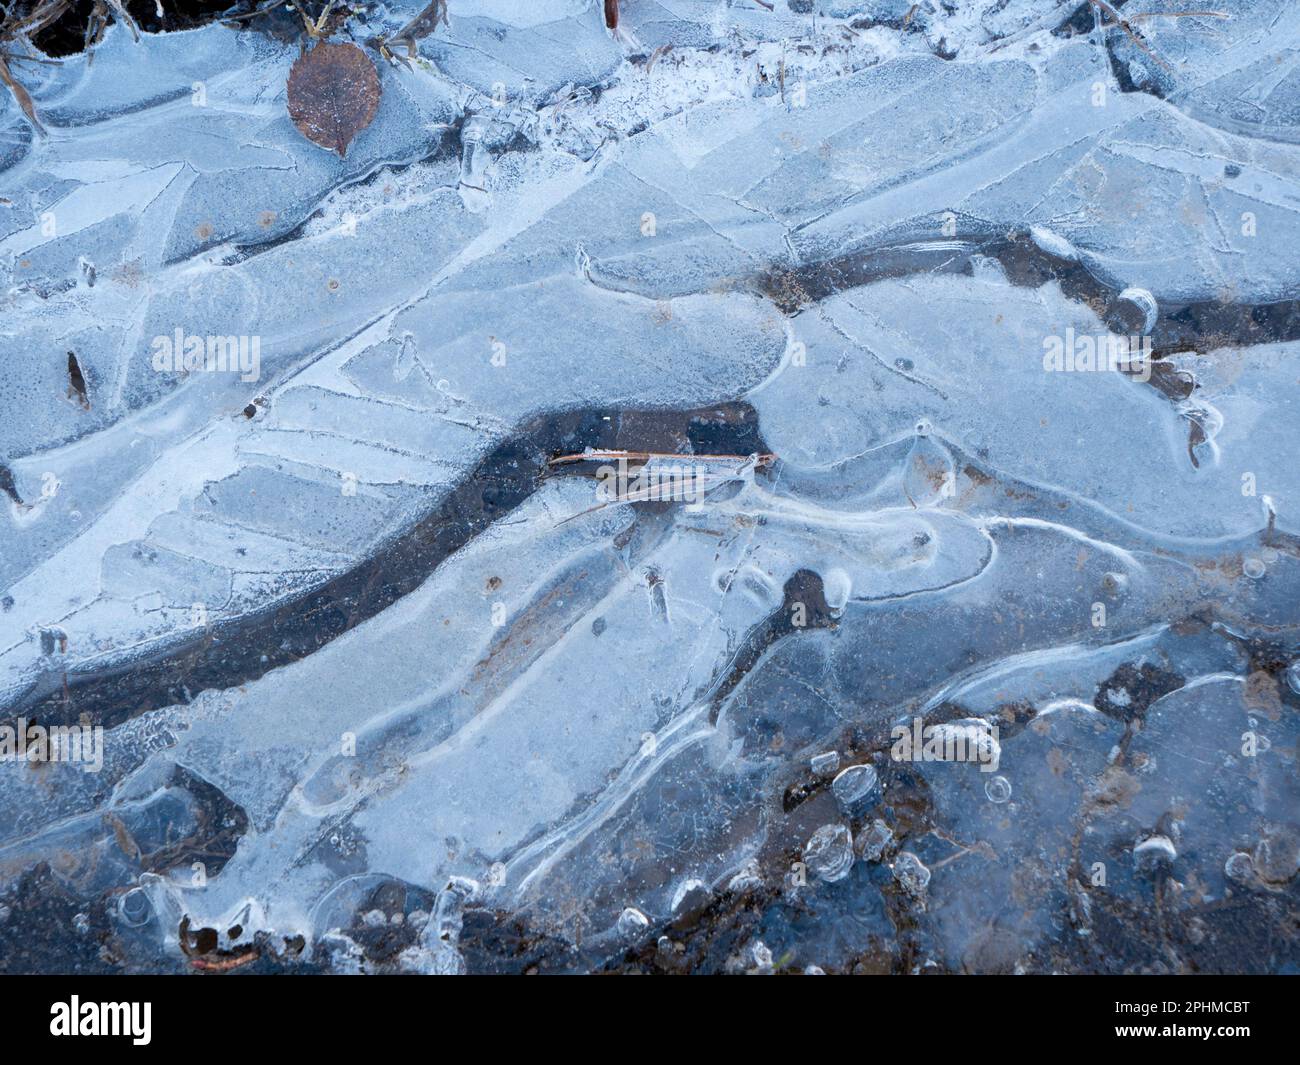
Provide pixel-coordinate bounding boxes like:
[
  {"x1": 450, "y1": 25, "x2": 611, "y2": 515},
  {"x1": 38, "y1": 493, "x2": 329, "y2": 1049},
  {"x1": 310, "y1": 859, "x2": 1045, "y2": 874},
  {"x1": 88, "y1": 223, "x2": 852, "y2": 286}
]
[{"x1": 289, "y1": 43, "x2": 380, "y2": 156}]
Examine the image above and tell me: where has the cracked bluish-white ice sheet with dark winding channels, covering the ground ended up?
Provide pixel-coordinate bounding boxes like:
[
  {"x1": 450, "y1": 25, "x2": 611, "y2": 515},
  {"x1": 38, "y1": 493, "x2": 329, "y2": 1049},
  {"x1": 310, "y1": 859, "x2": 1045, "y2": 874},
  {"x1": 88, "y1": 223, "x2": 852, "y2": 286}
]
[{"x1": 0, "y1": 0, "x2": 1300, "y2": 971}]
